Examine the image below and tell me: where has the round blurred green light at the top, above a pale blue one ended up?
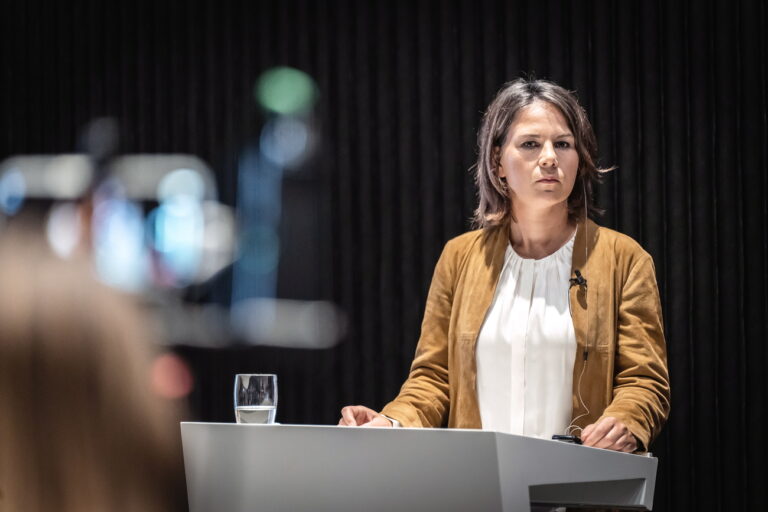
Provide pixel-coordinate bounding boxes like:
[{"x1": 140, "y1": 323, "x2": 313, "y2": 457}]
[{"x1": 254, "y1": 67, "x2": 317, "y2": 115}]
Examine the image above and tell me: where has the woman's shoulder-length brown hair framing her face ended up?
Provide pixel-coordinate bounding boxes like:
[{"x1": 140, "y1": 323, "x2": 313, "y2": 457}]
[{"x1": 474, "y1": 78, "x2": 608, "y2": 227}]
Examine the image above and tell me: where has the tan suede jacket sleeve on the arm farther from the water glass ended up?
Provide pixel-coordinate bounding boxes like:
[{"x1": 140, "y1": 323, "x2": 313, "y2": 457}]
[{"x1": 602, "y1": 254, "x2": 670, "y2": 451}]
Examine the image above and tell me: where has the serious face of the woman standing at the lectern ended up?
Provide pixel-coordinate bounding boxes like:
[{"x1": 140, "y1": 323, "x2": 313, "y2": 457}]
[{"x1": 496, "y1": 101, "x2": 579, "y2": 211}]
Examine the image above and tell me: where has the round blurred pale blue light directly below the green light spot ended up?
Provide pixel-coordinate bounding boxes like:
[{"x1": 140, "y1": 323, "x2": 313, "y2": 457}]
[{"x1": 260, "y1": 116, "x2": 311, "y2": 167}]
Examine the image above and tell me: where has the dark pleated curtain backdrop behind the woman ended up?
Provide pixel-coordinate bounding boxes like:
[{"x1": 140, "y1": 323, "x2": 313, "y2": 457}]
[{"x1": 0, "y1": 0, "x2": 768, "y2": 510}]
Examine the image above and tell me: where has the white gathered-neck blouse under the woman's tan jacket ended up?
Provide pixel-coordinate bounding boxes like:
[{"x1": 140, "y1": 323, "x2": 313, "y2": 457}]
[{"x1": 476, "y1": 233, "x2": 576, "y2": 438}]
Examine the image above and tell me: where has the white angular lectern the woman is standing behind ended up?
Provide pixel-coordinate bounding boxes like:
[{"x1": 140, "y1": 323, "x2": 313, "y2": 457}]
[{"x1": 181, "y1": 423, "x2": 657, "y2": 512}]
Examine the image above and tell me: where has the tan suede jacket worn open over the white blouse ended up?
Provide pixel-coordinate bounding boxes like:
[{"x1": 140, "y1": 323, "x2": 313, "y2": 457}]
[{"x1": 382, "y1": 221, "x2": 670, "y2": 450}]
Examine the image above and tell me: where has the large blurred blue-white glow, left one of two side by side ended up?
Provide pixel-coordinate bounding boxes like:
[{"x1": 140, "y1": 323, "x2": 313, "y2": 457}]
[{"x1": 93, "y1": 199, "x2": 148, "y2": 292}]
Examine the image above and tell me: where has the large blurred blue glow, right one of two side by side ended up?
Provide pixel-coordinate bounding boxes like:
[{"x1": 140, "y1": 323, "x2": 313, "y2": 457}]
[{"x1": 149, "y1": 196, "x2": 204, "y2": 286}]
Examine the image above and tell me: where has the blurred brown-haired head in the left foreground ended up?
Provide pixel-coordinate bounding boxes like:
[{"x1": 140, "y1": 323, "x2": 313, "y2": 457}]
[{"x1": 0, "y1": 226, "x2": 185, "y2": 511}]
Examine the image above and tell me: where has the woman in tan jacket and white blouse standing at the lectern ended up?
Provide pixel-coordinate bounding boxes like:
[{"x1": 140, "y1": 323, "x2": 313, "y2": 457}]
[{"x1": 339, "y1": 79, "x2": 670, "y2": 452}]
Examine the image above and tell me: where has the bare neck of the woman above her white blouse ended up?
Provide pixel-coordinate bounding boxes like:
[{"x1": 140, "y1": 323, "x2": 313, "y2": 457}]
[{"x1": 509, "y1": 203, "x2": 575, "y2": 260}]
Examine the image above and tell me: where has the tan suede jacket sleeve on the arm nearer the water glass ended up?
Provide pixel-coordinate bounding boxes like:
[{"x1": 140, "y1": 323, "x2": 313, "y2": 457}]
[{"x1": 381, "y1": 242, "x2": 456, "y2": 428}]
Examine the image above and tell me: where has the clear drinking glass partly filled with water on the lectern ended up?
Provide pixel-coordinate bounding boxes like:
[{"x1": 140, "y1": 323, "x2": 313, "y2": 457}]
[{"x1": 235, "y1": 373, "x2": 277, "y2": 423}]
